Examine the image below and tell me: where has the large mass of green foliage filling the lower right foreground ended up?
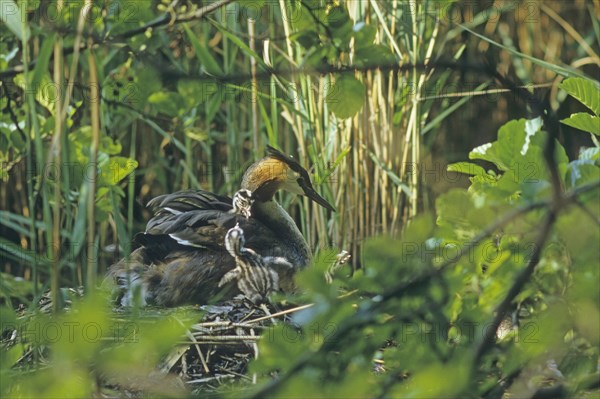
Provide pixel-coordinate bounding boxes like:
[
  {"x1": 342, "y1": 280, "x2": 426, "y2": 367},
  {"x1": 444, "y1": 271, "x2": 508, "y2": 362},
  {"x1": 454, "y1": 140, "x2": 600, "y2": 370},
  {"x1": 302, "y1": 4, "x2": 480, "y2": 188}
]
[{"x1": 251, "y1": 113, "x2": 600, "y2": 398}]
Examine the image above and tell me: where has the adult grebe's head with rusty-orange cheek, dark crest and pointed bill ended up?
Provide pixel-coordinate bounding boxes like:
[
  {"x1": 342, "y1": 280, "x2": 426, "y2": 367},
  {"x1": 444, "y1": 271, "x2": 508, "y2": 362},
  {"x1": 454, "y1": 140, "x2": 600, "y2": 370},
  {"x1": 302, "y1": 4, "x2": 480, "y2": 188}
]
[{"x1": 242, "y1": 146, "x2": 335, "y2": 212}]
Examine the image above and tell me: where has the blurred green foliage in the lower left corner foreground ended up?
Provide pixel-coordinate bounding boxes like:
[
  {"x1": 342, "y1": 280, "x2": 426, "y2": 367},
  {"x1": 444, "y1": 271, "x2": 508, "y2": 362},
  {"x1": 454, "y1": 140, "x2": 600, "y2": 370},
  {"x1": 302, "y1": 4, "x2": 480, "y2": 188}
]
[{"x1": 0, "y1": 292, "x2": 193, "y2": 398}]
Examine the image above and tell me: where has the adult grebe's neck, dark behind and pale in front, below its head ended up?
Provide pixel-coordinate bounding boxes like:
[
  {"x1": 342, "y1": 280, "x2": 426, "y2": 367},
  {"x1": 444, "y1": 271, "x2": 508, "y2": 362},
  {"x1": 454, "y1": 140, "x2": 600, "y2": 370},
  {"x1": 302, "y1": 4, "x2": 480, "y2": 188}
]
[{"x1": 252, "y1": 200, "x2": 312, "y2": 267}]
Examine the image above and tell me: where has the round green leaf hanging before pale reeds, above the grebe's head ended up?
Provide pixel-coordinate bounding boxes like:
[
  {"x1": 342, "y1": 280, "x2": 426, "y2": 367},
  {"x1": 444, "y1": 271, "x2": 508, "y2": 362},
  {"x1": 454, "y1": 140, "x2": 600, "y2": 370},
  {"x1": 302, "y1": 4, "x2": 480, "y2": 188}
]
[{"x1": 325, "y1": 75, "x2": 365, "y2": 119}]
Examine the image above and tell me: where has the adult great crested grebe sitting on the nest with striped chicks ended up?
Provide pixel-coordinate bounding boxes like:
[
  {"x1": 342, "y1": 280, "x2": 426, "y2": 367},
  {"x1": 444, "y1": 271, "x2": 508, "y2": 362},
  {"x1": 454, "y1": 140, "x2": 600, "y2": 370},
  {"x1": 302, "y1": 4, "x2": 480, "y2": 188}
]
[{"x1": 108, "y1": 146, "x2": 335, "y2": 306}]
